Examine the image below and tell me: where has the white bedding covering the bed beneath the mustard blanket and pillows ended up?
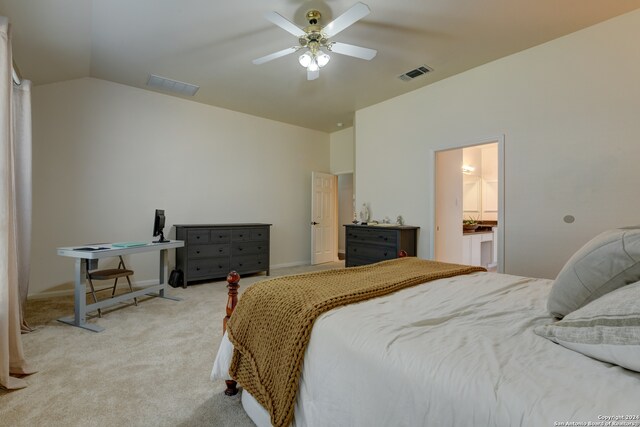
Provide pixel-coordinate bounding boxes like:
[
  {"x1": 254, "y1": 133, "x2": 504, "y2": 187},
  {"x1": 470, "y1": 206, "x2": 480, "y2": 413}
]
[{"x1": 212, "y1": 273, "x2": 640, "y2": 426}]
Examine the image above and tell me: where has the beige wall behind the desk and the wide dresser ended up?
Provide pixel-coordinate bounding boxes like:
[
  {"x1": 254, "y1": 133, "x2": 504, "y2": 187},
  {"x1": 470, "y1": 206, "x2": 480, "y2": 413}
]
[{"x1": 30, "y1": 79, "x2": 330, "y2": 294}]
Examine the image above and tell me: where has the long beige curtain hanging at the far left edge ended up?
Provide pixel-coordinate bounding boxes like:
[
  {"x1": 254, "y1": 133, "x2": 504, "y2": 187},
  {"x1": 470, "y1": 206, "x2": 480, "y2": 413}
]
[{"x1": 0, "y1": 16, "x2": 33, "y2": 389}]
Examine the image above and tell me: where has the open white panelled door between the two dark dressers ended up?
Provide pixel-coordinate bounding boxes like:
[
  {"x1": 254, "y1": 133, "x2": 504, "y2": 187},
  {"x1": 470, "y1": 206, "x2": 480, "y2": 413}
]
[{"x1": 311, "y1": 172, "x2": 338, "y2": 264}]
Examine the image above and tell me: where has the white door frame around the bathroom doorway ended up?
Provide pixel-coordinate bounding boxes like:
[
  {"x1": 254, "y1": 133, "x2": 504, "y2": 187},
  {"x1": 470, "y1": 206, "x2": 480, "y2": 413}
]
[{"x1": 428, "y1": 134, "x2": 505, "y2": 273}]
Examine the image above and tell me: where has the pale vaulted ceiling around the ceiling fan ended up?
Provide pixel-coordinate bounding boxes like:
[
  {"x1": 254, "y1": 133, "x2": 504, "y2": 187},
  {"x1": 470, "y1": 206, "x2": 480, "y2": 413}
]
[{"x1": 0, "y1": 0, "x2": 640, "y2": 132}]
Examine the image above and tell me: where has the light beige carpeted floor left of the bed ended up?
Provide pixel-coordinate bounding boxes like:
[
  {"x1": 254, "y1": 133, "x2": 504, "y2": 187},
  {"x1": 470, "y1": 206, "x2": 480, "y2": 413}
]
[{"x1": 0, "y1": 263, "x2": 344, "y2": 427}]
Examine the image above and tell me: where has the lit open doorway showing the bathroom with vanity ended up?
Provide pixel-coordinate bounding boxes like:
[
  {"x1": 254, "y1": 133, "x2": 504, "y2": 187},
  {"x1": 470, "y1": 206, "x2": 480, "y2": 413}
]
[{"x1": 433, "y1": 138, "x2": 504, "y2": 272}]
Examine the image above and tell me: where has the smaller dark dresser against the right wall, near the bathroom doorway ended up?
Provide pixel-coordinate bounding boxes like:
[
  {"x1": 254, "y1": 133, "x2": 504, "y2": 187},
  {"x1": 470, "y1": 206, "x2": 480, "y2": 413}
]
[{"x1": 345, "y1": 224, "x2": 420, "y2": 267}]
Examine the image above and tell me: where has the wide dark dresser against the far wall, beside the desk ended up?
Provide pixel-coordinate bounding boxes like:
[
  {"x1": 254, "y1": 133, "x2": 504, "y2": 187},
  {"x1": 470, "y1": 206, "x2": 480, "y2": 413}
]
[{"x1": 175, "y1": 224, "x2": 271, "y2": 286}]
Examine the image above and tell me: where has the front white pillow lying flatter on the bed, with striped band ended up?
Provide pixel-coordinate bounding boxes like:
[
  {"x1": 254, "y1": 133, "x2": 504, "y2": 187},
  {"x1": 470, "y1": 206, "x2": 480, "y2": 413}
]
[{"x1": 534, "y1": 282, "x2": 640, "y2": 372}]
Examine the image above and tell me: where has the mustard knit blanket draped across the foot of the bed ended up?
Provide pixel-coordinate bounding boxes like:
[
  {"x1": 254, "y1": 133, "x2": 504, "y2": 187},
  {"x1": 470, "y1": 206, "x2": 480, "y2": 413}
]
[{"x1": 227, "y1": 257, "x2": 485, "y2": 427}]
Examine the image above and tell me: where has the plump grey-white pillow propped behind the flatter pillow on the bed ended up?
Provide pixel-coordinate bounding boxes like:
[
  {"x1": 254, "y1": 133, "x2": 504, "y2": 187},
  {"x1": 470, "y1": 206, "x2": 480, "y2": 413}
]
[{"x1": 547, "y1": 227, "x2": 640, "y2": 318}]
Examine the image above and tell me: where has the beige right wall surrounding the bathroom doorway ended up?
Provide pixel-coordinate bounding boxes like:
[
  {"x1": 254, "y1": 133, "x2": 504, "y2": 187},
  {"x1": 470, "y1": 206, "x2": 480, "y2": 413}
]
[{"x1": 355, "y1": 11, "x2": 640, "y2": 278}]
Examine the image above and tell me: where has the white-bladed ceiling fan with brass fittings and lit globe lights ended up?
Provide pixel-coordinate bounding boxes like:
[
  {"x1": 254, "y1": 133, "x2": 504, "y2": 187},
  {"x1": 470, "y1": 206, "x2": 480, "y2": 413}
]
[{"x1": 252, "y1": 2, "x2": 378, "y2": 80}]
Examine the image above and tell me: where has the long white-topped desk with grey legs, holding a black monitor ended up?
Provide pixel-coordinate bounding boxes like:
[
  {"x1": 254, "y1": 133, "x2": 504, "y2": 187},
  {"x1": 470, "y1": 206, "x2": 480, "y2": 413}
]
[{"x1": 58, "y1": 240, "x2": 184, "y2": 332}]
